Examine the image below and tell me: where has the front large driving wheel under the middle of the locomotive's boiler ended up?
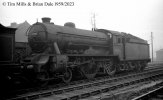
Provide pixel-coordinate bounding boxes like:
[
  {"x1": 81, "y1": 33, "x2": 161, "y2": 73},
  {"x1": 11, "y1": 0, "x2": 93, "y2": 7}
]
[{"x1": 80, "y1": 62, "x2": 99, "y2": 79}]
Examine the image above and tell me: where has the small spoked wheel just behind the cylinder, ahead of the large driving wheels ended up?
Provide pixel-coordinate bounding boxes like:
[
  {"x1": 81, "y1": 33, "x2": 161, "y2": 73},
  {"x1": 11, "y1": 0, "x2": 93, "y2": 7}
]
[{"x1": 62, "y1": 68, "x2": 72, "y2": 83}]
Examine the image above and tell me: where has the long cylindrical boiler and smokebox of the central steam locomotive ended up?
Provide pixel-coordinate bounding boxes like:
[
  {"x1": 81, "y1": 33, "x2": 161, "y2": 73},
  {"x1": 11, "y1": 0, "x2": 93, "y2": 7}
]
[{"x1": 28, "y1": 18, "x2": 110, "y2": 55}]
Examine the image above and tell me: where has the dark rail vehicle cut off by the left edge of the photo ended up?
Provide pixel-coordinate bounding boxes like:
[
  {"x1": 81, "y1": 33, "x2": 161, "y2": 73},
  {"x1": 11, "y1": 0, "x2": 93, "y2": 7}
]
[{"x1": 0, "y1": 24, "x2": 21, "y2": 91}]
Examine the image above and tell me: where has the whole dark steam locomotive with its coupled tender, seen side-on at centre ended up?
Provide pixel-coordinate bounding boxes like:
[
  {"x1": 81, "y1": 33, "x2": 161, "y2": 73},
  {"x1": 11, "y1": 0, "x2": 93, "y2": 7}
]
[{"x1": 24, "y1": 17, "x2": 150, "y2": 82}]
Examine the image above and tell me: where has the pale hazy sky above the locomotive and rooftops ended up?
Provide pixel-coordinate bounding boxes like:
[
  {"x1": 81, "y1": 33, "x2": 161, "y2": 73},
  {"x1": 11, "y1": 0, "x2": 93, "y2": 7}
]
[{"x1": 0, "y1": 0, "x2": 163, "y2": 57}]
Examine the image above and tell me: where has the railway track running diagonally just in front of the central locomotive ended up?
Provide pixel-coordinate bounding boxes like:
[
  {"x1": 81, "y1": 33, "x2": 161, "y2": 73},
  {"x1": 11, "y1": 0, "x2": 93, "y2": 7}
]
[{"x1": 6, "y1": 65, "x2": 163, "y2": 100}]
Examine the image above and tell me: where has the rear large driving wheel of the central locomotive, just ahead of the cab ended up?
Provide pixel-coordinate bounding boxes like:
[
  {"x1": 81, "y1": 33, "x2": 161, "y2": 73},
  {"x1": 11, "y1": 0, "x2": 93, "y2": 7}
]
[{"x1": 104, "y1": 61, "x2": 116, "y2": 76}]
